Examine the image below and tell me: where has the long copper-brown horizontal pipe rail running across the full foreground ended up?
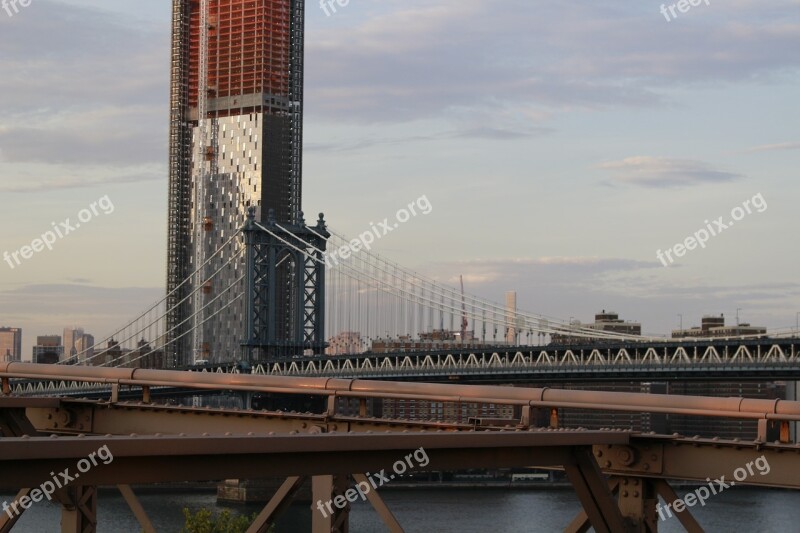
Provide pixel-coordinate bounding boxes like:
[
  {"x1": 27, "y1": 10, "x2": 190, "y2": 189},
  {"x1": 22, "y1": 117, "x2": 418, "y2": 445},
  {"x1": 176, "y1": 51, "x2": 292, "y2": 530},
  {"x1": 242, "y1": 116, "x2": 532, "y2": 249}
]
[{"x1": 0, "y1": 362, "x2": 800, "y2": 420}]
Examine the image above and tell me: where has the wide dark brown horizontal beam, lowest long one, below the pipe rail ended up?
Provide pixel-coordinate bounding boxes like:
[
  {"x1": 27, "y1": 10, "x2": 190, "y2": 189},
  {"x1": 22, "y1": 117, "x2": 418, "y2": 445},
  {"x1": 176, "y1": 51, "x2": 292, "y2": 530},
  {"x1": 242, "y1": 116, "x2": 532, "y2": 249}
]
[{"x1": 0, "y1": 430, "x2": 629, "y2": 489}]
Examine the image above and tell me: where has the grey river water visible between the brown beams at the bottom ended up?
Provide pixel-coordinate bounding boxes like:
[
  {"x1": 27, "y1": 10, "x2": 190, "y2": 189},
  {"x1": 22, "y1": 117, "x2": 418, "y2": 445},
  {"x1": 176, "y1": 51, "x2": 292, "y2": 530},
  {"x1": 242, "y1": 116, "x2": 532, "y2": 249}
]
[{"x1": 0, "y1": 486, "x2": 800, "y2": 533}]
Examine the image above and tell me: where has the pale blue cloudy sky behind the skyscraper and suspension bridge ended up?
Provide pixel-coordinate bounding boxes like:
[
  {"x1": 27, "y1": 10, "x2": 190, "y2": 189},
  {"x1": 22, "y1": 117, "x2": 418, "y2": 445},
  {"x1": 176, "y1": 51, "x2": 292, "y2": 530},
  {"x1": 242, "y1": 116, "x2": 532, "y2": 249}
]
[{"x1": 0, "y1": 0, "x2": 800, "y2": 359}]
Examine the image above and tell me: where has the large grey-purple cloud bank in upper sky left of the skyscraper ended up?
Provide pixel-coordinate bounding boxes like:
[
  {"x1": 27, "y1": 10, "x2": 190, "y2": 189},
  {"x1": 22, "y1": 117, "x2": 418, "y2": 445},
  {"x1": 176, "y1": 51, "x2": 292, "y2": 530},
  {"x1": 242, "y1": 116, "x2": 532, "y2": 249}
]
[{"x1": 0, "y1": 0, "x2": 169, "y2": 192}]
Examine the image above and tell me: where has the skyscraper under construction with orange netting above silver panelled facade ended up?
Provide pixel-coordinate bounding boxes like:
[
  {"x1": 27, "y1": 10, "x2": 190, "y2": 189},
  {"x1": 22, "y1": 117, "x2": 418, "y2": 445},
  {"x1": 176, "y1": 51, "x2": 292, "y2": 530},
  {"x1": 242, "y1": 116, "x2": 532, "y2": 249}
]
[{"x1": 166, "y1": 0, "x2": 304, "y2": 366}]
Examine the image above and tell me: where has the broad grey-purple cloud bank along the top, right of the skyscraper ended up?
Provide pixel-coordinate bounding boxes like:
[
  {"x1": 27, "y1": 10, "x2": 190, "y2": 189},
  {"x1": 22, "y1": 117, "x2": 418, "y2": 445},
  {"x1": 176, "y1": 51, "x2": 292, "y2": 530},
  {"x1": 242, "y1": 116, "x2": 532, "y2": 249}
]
[{"x1": 306, "y1": 0, "x2": 800, "y2": 124}]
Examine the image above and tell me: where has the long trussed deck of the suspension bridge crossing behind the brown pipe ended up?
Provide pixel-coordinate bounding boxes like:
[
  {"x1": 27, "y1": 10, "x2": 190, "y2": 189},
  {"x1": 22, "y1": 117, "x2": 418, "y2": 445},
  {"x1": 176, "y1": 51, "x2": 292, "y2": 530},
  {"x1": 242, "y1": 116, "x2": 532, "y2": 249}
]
[{"x1": 7, "y1": 337, "x2": 800, "y2": 397}]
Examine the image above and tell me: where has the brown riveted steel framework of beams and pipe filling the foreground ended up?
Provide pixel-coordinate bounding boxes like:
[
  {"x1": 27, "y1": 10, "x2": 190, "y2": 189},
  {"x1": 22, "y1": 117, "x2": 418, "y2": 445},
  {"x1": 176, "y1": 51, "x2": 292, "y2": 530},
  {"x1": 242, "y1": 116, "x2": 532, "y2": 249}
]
[{"x1": 0, "y1": 363, "x2": 800, "y2": 533}]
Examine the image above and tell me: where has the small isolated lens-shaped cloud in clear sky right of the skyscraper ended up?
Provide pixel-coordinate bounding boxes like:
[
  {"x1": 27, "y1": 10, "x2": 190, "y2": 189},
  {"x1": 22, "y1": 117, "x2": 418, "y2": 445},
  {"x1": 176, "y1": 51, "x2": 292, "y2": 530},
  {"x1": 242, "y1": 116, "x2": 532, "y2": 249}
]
[{"x1": 597, "y1": 156, "x2": 743, "y2": 188}]
